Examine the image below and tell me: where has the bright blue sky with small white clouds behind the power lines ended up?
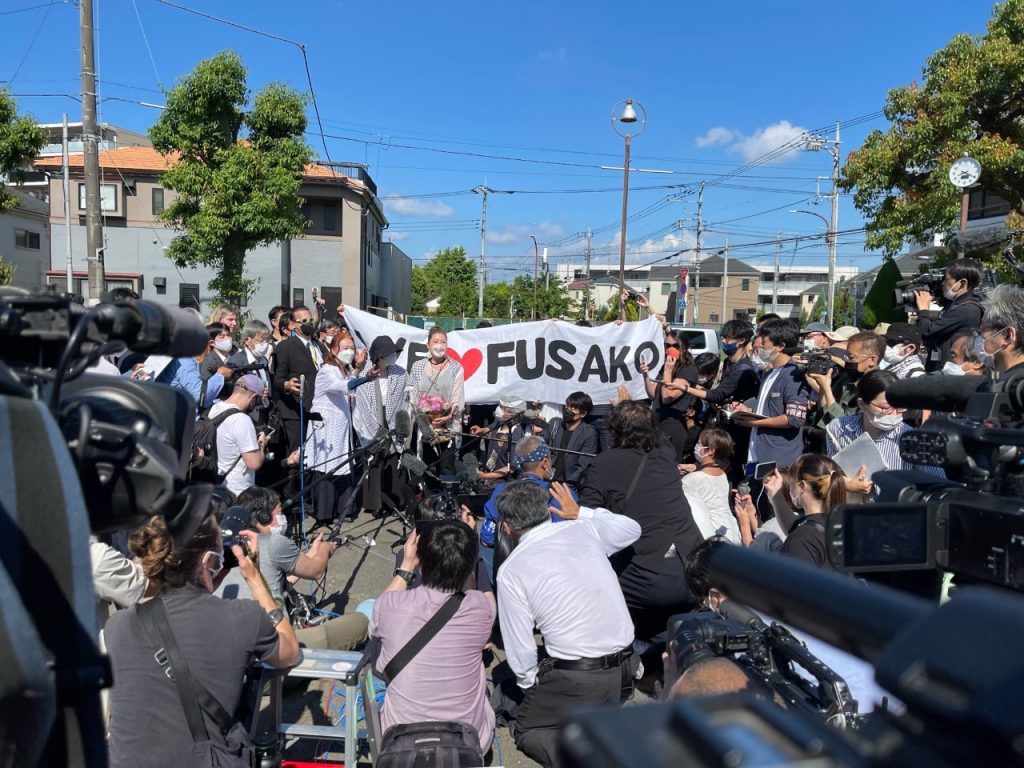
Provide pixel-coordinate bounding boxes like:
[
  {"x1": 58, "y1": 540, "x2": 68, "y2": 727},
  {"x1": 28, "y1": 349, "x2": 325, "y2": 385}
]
[{"x1": 0, "y1": 0, "x2": 992, "y2": 280}]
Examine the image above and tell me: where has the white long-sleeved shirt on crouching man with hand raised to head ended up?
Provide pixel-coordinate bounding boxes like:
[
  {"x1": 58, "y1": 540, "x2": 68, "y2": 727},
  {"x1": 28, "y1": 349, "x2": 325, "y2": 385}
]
[{"x1": 498, "y1": 507, "x2": 640, "y2": 688}]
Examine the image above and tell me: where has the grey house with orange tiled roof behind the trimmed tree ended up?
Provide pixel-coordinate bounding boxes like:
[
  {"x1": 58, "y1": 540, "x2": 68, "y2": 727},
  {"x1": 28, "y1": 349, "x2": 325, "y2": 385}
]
[{"x1": 29, "y1": 146, "x2": 403, "y2": 317}]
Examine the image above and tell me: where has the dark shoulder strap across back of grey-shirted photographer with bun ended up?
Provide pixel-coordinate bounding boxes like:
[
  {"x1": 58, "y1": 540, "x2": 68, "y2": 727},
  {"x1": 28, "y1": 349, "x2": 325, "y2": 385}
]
[{"x1": 135, "y1": 595, "x2": 232, "y2": 743}]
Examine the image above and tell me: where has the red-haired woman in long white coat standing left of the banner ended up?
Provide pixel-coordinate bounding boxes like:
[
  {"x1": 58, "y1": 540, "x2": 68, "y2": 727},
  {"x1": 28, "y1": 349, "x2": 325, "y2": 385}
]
[{"x1": 305, "y1": 331, "x2": 358, "y2": 525}]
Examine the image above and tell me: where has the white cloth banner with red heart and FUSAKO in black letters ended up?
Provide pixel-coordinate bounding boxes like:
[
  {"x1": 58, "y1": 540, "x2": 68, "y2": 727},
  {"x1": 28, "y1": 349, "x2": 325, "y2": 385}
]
[{"x1": 345, "y1": 307, "x2": 665, "y2": 403}]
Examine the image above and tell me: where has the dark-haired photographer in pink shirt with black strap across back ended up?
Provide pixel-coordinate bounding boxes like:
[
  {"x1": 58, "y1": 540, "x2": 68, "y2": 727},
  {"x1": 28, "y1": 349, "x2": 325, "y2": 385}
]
[{"x1": 370, "y1": 518, "x2": 497, "y2": 754}]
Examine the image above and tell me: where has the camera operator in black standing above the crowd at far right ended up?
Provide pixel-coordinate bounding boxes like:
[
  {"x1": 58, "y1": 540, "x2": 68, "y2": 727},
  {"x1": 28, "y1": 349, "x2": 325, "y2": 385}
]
[{"x1": 911, "y1": 259, "x2": 984, "y2": 371}]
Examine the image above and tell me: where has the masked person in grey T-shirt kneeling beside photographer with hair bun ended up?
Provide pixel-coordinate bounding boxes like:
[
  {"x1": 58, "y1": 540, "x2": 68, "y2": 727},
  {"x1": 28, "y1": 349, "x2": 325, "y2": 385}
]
[{"x1": 216, "y1": 487, "x2": 369, "y2": 650}]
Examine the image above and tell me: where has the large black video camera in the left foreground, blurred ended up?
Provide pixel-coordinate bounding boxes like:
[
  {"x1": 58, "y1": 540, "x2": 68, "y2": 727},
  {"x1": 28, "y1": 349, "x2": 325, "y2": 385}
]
[{"x1": 0, "y1": 288, "x2": 212, "y2": 766}]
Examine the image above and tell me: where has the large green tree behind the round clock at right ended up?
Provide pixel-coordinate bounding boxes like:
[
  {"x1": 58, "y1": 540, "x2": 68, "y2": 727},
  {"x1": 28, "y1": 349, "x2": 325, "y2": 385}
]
[{"x1": 840, "y1": 0, "x2": 1024, "y2": 255}]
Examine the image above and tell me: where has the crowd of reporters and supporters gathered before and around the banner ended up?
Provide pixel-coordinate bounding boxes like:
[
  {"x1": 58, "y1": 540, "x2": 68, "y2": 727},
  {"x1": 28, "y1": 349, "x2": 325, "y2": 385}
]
[{"x1": 83, "y1": 259, "x2": 1011, "y2": 766}]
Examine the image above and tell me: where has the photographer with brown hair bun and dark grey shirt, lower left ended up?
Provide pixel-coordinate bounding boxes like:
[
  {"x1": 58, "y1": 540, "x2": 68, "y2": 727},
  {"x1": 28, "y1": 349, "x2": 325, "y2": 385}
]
[{"x1": 104, "y1": 515, "x2": 299, "y2": 768}]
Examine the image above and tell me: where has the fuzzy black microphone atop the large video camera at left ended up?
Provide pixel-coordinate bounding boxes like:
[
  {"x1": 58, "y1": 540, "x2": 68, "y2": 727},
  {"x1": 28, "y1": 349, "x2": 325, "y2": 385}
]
[{"x1": 93, "y1": 299, "x2": 210, "y2": 357}]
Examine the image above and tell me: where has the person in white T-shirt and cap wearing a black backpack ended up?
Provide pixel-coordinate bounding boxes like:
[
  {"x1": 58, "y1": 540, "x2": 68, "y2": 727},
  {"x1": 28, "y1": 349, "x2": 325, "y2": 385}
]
[{"x1": 210, "y1": 374, "x2": 267, "y2": 495}]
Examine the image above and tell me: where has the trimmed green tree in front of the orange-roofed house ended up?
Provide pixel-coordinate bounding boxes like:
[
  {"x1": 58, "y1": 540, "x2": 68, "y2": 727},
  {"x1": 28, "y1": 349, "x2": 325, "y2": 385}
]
[{"x1": 150, "y1": 51, "x2": 312, "y2": 304}]
